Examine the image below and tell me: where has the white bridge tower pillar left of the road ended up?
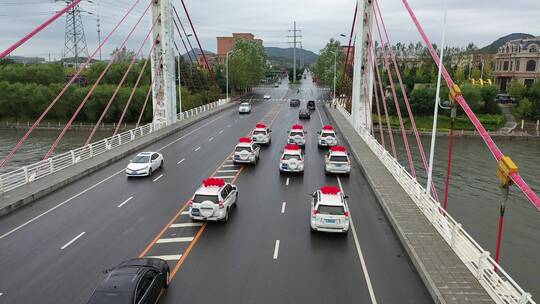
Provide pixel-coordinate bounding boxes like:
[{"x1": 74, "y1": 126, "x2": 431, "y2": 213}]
[{"x1": 151, "y1": 0, "x2": 178, "y2": 129}]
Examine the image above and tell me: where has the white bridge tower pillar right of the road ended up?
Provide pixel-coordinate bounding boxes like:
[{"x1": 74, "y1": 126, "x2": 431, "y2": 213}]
[{"x1": 351, "y1": 0, "x2": 373, "y2": 131}]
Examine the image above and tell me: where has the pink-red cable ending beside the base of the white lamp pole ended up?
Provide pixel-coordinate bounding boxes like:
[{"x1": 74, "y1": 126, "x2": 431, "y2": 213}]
[{"x1": 373, "y1": 0, "x2": 439, "y2": 201}]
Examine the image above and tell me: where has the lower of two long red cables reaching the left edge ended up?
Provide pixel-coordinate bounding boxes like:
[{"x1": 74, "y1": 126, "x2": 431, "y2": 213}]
[{"x1": 0, "y1": 0, "x2": 144, "y2": 168}]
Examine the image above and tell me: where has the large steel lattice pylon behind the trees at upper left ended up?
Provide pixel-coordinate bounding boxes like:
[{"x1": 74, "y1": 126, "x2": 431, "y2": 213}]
[{"x1": 56, "y1": 0, "x2": 88, "y2": 67}]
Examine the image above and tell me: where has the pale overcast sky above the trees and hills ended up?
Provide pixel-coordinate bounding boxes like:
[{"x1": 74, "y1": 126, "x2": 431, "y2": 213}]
[{"x1": 0, "y1": 0, "x2": 540, "y2": 58}]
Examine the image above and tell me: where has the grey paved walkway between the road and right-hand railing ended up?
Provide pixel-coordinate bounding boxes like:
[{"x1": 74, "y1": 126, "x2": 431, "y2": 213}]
[{"x1": 326, "y1": 108, "x2": 493, "y2": 303}]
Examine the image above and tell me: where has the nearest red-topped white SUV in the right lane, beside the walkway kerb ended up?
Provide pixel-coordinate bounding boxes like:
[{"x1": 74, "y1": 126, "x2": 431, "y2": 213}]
[{"x1": 310, "y1": 186, "x2": 349, "y2": 233}]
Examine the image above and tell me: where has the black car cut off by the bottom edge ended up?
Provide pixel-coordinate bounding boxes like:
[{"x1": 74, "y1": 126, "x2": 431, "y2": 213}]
[{"x1": 88, "y1": 258, "x2": 169, "y2": 304}]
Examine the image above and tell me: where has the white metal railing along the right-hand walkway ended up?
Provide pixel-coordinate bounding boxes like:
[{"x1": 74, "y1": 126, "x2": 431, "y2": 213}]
[{"x1": 337, "y1": 106, "x2": 536, "y2": 304}]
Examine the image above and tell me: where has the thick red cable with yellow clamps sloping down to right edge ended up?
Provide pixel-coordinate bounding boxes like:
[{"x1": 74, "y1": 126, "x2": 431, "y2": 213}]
[{"x1": 402, "y1": 0, "x2": 540, "y2": 211}]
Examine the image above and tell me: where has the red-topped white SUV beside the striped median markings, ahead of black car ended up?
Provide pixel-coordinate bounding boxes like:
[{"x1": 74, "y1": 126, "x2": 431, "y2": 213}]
[{"x1": 189, "y1": 178, "x2": 238, "y2": 222}]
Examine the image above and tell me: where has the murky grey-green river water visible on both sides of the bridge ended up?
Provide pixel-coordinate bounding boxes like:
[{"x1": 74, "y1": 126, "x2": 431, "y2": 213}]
[{"x1": 0, "y1": 130, "x2": 540, "y2": 301}]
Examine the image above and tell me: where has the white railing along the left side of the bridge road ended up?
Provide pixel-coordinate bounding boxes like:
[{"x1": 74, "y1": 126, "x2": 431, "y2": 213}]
[{"x1": 0, "y1": 99, "x2": 227, "y2": 194}]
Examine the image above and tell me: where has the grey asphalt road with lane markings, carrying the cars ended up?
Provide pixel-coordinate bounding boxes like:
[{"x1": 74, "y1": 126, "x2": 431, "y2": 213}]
[{"x1": 0, "y1": 77, "x2": 431, "y2": 304}]
